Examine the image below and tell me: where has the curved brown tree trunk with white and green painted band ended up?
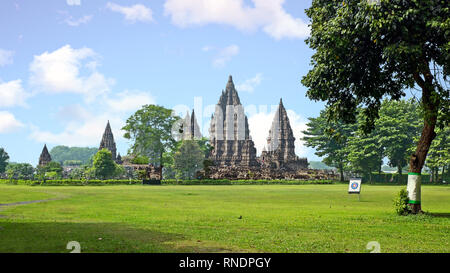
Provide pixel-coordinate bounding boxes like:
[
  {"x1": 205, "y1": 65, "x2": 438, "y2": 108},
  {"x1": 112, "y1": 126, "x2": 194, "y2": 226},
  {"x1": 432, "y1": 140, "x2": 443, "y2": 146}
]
[{"x1": 407, "y1": 67, "x2": 439, "y2": 214}]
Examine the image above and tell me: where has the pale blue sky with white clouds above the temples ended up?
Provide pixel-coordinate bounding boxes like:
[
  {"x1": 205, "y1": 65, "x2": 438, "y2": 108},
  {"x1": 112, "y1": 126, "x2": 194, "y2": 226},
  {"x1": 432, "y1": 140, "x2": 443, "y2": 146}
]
[{"x1": 0, "y1": 0, "x2": 330, "y2": 164}]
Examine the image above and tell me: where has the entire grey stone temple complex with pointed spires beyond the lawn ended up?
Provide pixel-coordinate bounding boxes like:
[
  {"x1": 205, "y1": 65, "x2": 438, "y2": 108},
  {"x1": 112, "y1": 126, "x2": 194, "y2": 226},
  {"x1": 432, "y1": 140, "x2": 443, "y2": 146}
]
[{"x1": 84, "y1": 76, "x2": 314, "y2": 179}]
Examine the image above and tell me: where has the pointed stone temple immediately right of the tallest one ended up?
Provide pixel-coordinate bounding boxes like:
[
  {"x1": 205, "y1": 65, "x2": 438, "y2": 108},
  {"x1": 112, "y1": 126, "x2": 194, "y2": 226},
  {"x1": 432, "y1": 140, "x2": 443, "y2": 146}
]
[{"x1": 260, "y1": 99, "x2": 308, "y2": 170}]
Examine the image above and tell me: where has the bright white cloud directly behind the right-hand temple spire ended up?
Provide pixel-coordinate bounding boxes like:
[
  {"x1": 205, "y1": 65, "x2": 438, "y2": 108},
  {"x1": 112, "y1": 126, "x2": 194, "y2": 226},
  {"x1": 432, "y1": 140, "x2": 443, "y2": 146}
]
[{"x1": 248, "y1": 106, "x2": 306, "y2": 157}]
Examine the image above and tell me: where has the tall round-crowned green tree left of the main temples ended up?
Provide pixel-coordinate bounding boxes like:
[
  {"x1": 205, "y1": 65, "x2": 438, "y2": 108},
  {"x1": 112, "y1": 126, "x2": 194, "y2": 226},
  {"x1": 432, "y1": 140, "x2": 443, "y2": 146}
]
[{"x1": 122, "y1": 105, "x2": 179, "y2": 165}]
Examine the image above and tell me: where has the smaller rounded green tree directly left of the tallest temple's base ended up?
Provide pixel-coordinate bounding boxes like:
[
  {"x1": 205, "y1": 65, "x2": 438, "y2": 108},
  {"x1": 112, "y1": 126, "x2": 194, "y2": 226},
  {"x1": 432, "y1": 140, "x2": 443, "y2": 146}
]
[{"x1": 174, "y1": 140, "x2": 205, "y2": 179}]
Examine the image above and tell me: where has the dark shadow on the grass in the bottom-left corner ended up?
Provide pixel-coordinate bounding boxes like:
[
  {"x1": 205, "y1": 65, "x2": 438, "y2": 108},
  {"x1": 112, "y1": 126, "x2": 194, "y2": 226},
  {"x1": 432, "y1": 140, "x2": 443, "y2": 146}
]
[{"x1": 0, "y1": 218, "x2": 239, "y2": 253}]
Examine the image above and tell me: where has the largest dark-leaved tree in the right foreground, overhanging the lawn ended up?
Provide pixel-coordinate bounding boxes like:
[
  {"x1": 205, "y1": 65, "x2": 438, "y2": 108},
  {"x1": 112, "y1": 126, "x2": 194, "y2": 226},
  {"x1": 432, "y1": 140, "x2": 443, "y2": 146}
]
[{"x1": 302, "y1": 0, "x2": 450, "y2": 213}]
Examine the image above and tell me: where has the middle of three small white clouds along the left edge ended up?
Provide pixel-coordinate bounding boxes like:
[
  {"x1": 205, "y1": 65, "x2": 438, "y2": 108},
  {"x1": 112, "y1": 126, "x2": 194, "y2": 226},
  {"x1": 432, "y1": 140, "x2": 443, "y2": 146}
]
[{"x1": 0, "y1": 80, "x2": 30, "y2": 107}]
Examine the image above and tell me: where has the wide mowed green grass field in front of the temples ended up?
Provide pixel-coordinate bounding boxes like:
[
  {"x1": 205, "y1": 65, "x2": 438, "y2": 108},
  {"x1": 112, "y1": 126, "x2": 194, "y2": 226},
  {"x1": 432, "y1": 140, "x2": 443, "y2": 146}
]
[{"x1": 0, "y1": 184, "x2": 450, "y2": 253}]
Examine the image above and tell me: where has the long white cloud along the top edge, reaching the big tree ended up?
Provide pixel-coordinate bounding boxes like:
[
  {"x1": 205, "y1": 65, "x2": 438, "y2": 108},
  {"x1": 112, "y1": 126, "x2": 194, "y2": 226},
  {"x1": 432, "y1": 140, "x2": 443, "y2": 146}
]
[{"x1": 164, "y1": 0, "x2": 309, "y2": 40}]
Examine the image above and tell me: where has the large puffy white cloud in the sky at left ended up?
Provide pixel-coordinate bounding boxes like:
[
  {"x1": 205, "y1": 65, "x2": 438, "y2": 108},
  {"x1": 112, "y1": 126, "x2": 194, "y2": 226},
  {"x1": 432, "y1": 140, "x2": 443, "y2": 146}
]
[{"x1": 30, "y1": 45, "x2": 114, "y2": 102}]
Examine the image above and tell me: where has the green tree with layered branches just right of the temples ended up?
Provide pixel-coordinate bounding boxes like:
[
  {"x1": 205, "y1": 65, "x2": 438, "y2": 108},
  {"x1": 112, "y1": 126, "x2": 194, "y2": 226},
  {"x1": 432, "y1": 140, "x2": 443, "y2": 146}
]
[{"x1": 302, "y1": 108, "x2": 355, "y2": 181}]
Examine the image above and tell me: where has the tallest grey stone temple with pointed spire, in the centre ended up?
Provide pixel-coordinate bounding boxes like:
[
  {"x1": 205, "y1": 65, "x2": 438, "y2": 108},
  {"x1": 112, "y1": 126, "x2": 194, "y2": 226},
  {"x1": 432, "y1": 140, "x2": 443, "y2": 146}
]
[{"x1": 209, "y1": 76, "x2": 258, "y2": 167}]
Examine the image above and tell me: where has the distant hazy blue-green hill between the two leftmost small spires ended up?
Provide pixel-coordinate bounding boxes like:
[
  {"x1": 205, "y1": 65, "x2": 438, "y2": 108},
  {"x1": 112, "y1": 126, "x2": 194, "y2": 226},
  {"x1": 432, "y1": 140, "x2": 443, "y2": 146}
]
[{"x1": 50, "y1": 146, "x2": 98, "y2": 165}]
